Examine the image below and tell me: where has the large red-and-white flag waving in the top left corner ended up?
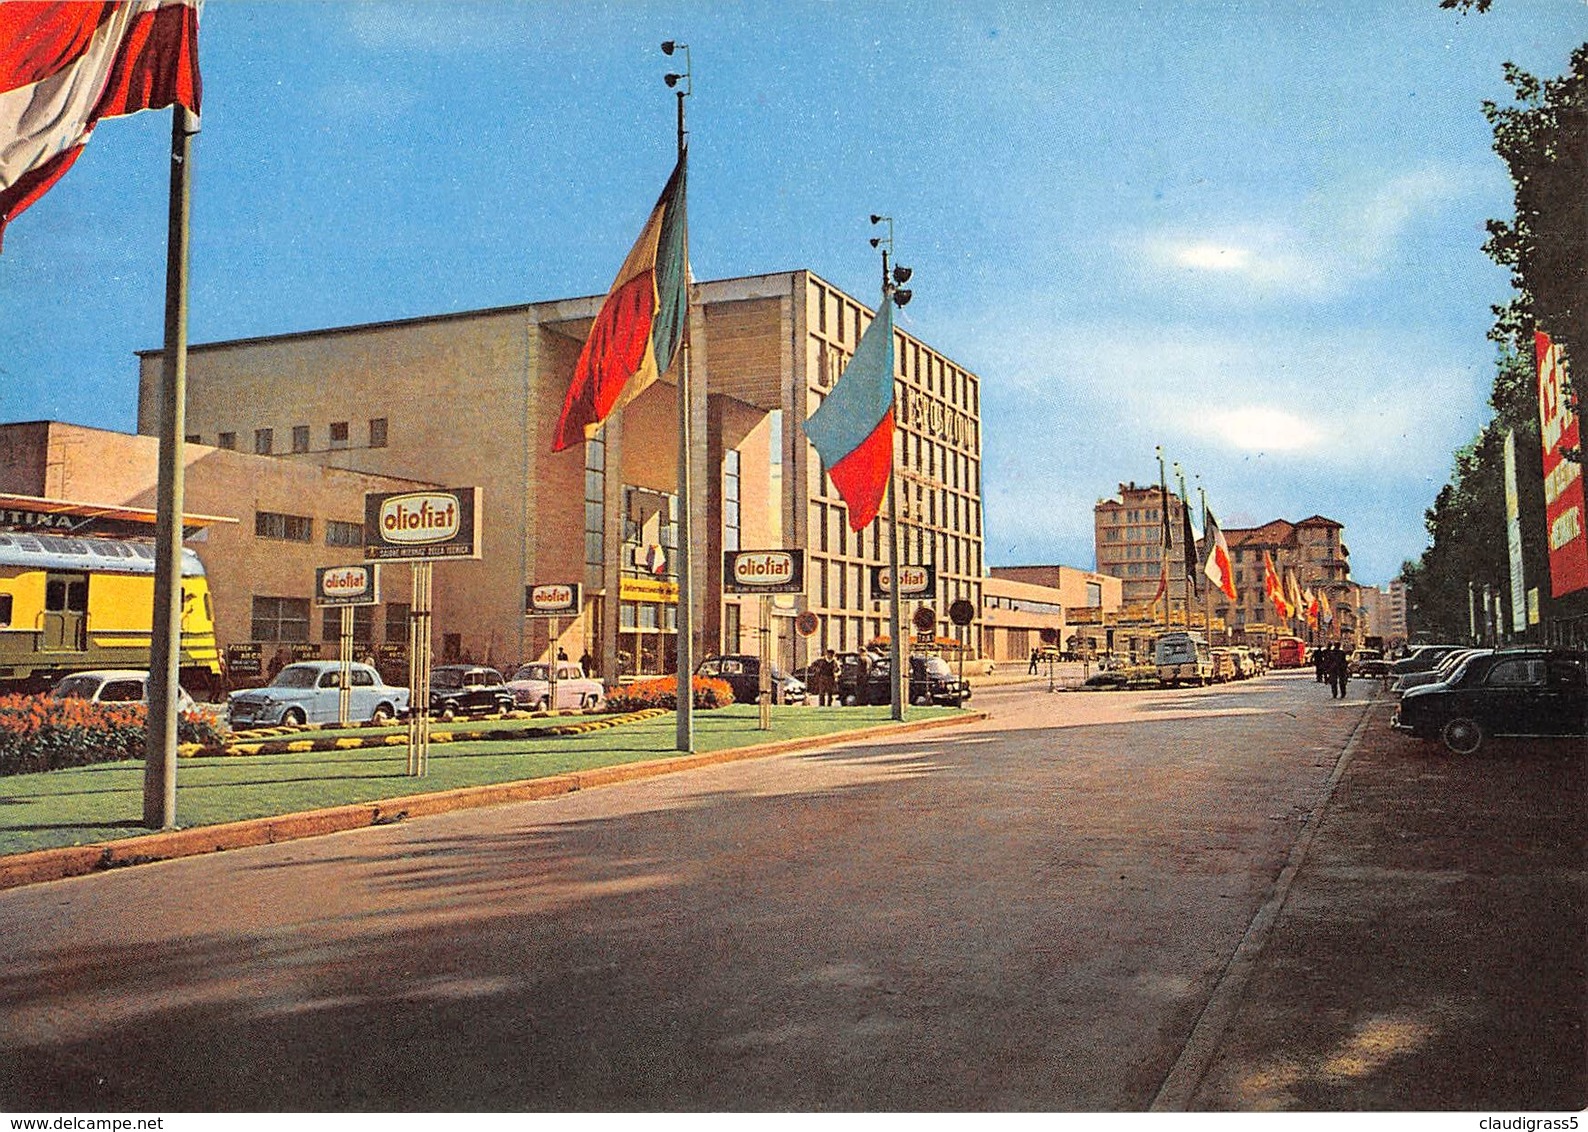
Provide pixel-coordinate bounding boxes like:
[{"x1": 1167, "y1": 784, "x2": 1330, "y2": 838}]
[{"x1": 0, "y1": 0, "x2": 200, "y2": 252}]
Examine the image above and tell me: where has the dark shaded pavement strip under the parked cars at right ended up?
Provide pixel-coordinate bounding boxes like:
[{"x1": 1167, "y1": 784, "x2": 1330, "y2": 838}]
[{"x1": 1175, "y1": 699, "x2": 1588, "y2": 1113}]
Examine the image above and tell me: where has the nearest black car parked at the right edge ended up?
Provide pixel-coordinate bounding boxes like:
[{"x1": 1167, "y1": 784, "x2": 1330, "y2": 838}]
[{"x1": 1390, "y1": 648, "x2": 1588, "y2": 754}]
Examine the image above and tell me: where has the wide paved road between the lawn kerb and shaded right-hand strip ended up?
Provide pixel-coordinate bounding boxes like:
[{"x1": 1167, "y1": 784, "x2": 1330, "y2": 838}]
[{"x1": 0, "y1": 676, "x2": 1364, "y2": 1111}]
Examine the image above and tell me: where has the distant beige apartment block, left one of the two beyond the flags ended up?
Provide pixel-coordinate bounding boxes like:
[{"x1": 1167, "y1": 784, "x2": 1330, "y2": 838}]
[{"x1": 1093, "y1": 483, "x2": 1197, "y2": 619}]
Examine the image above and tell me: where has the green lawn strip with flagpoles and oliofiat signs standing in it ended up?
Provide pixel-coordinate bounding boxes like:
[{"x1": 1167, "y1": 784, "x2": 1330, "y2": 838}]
[{"x1": 0, "y1": 705, "x2": 958, "y2": 856}]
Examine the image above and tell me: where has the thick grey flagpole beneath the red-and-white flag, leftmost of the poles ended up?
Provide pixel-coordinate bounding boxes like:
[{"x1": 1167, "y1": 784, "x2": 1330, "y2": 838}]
[{"x1": 143, "y1": 103, "x2": 197, "y2": 829}]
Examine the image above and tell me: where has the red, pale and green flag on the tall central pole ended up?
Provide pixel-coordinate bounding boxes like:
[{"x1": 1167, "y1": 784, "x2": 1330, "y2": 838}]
[{"x1": 551, "y1": 154, "x2": 689, "y2": 452}]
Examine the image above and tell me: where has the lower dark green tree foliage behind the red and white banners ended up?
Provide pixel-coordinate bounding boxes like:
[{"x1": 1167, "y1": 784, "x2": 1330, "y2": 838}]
[{"x1": 1401, "y1": 349, "x2": 1548, "y2": 640}]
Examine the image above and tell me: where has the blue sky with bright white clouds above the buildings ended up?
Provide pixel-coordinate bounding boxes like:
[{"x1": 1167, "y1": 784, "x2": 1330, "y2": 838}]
[{"x1": 0, "y1": 0, "x2": 1588, "y2": 583}]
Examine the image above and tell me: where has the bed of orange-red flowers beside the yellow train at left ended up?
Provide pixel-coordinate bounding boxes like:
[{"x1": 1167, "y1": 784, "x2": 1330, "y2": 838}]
[{"x1": 0, "y1": 695, "x2": 221, "y2": 776}]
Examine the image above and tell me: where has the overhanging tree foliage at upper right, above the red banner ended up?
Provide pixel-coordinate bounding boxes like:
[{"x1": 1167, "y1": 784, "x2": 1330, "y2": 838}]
[{"x1": 1483, "y1": 43, "x2": 1588, "y2": 365}]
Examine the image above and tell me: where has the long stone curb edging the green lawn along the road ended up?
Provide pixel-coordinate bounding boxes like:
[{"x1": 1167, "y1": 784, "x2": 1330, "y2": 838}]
[{"x1": 0, "y1": 711, "x2": 989, "y2": 889}]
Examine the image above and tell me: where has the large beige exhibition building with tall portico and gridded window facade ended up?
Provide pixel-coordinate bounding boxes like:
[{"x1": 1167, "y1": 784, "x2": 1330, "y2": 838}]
[{"x1": 138, "y1": 271, "x2": 983, "y2": 675}]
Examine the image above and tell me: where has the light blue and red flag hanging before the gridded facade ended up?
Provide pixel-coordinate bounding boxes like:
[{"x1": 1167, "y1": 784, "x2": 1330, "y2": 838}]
[{"x1": 805, "y1": 295, "x2": 894, "y2": 530}]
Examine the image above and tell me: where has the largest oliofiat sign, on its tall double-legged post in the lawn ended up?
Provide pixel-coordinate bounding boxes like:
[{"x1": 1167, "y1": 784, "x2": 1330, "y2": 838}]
[{"x1": 364, "y1": 487, "x2": 480, "y2": 778}]
